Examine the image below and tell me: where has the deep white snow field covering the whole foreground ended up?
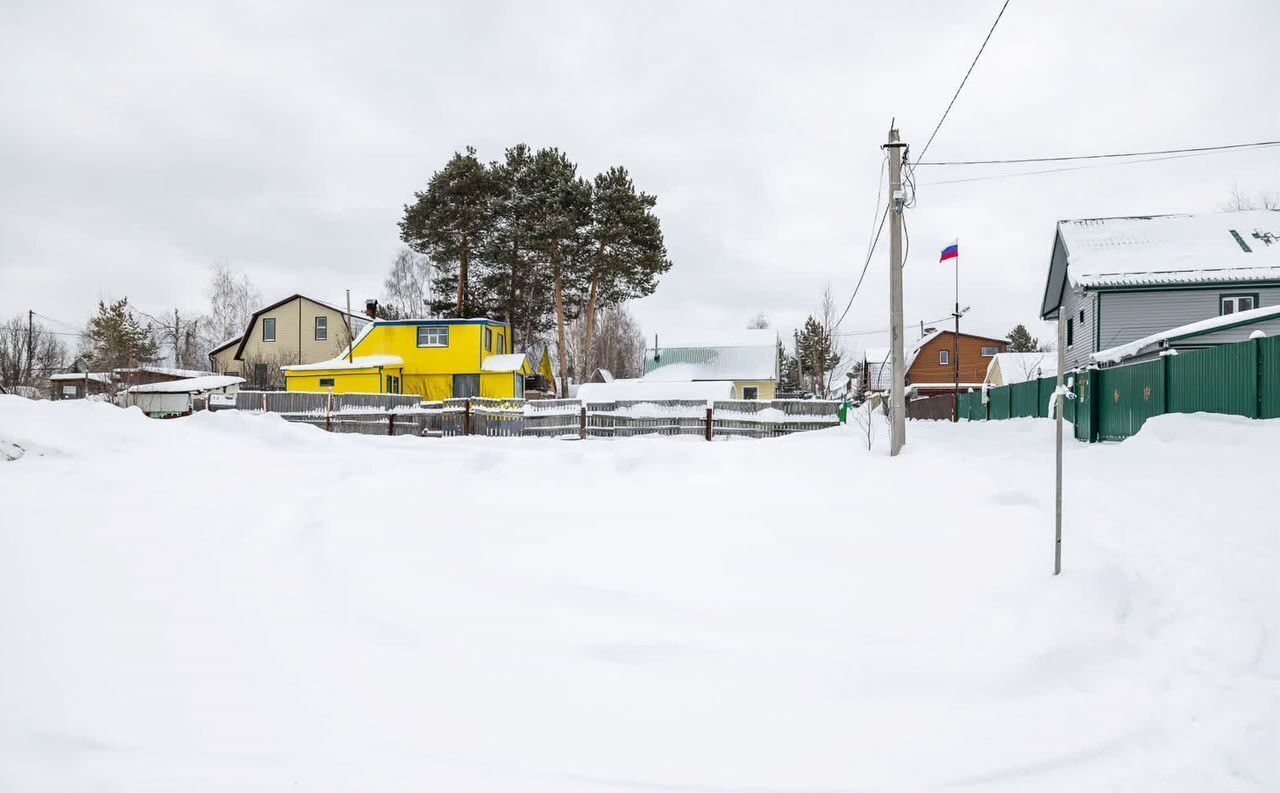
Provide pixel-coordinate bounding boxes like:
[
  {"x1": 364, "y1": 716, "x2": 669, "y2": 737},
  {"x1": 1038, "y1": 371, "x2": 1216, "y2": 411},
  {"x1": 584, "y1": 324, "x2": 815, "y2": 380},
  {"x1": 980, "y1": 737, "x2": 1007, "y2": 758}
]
[{"x1": 0, "y1": 397, "x2": 1280, "y2": 793}]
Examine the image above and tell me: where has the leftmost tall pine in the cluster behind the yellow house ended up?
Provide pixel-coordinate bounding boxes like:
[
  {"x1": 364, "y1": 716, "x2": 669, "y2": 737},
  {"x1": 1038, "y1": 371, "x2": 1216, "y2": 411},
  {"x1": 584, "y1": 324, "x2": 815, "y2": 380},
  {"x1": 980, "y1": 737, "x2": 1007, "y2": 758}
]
[{"x1": 399, "y1": 146, "x2": 497, "y2": 317}]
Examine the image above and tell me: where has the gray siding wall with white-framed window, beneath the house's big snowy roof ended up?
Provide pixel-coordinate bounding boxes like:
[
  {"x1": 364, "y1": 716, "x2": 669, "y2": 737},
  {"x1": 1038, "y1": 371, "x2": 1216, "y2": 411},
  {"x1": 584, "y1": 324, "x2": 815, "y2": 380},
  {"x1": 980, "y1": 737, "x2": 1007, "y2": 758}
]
[{"x1": 1091, "y1": 287, "x2": 1280, "y2": 349}]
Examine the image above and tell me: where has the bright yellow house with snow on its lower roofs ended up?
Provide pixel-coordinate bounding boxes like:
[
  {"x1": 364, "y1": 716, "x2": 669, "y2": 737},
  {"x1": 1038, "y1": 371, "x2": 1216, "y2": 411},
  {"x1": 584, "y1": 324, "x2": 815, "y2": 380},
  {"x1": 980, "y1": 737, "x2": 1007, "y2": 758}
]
[{"x1": 282, "y1": 318, "x2": 532, "y2": 402}]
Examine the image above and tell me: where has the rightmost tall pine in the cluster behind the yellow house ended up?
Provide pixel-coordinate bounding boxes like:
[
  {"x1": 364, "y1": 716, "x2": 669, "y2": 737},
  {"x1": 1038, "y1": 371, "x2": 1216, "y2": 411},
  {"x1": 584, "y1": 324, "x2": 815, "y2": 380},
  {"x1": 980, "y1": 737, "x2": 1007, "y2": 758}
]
[{"x1": 584, "y1": 166, "x2": 671, "y2": 371}]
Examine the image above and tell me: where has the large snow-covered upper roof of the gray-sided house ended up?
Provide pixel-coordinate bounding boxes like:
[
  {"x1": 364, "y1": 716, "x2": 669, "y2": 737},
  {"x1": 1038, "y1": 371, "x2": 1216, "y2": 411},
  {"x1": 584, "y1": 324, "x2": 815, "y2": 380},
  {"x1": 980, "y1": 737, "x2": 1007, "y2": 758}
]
[{"x1": 1057, "y1": 210, "x2": 1280, "y2": 288}]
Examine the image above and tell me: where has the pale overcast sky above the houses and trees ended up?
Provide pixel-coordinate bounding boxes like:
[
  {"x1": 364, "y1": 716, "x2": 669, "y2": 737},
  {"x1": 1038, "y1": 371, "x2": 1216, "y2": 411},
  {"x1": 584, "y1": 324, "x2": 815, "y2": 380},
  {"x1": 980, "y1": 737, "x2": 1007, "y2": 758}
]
[{"x1": 0, "y1": 0, "x2": 1280, "y2": 345}]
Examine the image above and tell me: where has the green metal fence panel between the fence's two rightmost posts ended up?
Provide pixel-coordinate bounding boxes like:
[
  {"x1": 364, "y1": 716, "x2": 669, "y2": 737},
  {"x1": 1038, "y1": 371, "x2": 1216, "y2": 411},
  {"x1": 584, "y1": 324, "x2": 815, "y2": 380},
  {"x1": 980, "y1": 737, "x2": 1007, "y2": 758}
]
[{"x1": 1164, "y1": 342, "x2": 1258, "y2": 418}]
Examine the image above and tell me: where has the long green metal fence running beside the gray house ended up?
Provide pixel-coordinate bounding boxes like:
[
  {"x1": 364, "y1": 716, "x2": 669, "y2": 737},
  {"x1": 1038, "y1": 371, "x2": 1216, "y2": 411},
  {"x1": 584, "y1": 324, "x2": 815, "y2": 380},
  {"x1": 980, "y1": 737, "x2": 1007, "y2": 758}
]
[{"x1": 960, "y1": 336, "x2": 1280, "y2": 443}]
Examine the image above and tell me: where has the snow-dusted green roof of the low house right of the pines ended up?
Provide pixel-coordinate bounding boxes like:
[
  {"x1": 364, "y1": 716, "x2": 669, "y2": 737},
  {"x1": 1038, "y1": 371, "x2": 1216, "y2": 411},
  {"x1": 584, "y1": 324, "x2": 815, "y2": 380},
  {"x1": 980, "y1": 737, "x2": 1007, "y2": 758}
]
[{"x1": 644, "y1": 329, "x2": 778, "y2": 380}]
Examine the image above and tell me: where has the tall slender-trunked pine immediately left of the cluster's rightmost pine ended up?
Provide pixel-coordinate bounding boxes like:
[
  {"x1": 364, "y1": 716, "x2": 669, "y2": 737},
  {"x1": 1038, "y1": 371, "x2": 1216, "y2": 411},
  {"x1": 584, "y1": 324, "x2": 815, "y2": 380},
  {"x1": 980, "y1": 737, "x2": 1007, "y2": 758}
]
[{"x1": 517, "y1": 148, "x2": 591, "y2": 386}]
